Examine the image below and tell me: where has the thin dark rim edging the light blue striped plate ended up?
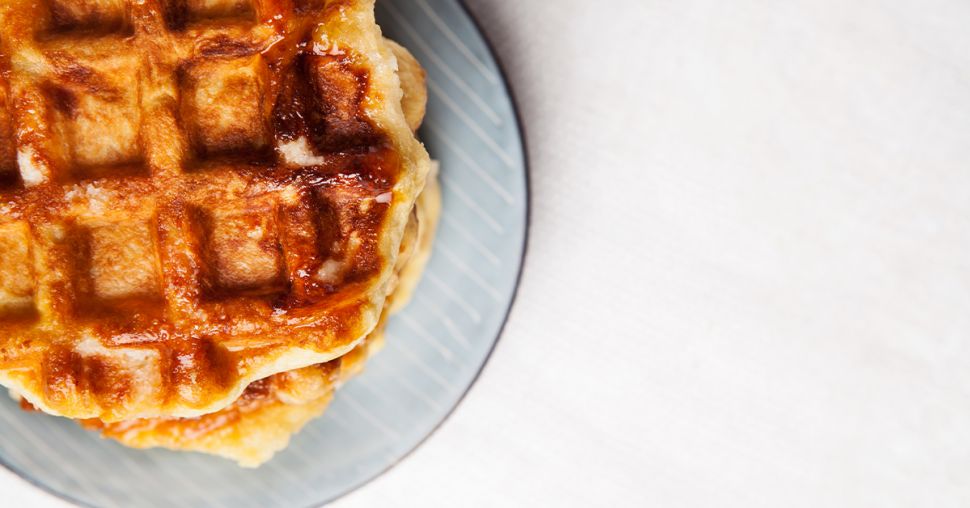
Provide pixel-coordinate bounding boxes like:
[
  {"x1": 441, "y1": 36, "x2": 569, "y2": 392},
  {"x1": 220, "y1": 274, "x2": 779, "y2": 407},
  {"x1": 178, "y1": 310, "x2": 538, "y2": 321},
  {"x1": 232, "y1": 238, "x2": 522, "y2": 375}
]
[{"x1": 0, "y1": 0, "x2": 532, "y2": 508}]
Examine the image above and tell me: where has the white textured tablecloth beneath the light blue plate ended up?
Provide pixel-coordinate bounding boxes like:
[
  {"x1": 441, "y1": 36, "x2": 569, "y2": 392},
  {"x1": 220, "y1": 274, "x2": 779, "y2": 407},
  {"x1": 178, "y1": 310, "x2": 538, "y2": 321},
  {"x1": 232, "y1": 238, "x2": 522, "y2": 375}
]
[{"x1": 7, "y1": 0, "x2": 970, "y2": 508}]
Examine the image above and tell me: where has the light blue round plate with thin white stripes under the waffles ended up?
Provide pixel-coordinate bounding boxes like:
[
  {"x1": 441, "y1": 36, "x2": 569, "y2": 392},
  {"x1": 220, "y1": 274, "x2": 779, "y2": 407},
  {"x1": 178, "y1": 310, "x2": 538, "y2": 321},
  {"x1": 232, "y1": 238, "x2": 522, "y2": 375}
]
[{"x1": 0, "y1": 0, "x2": 528, "y2": 508}]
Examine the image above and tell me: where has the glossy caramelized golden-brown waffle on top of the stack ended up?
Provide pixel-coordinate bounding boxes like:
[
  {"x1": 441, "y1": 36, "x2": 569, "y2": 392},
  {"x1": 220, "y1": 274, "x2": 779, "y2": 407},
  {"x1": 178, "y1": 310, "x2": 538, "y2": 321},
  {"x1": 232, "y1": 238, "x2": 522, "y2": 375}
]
[{"x1": 0, "y1": 0, "x2": 429, "y2": 422}]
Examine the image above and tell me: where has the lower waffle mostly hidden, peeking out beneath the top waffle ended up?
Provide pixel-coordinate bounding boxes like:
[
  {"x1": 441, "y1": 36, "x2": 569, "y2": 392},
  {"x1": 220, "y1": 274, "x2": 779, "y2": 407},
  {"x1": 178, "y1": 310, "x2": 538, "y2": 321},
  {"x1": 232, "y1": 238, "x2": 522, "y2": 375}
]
[{"x1": 73, "y1": 41, "x2": 441, "y2": 467}]
